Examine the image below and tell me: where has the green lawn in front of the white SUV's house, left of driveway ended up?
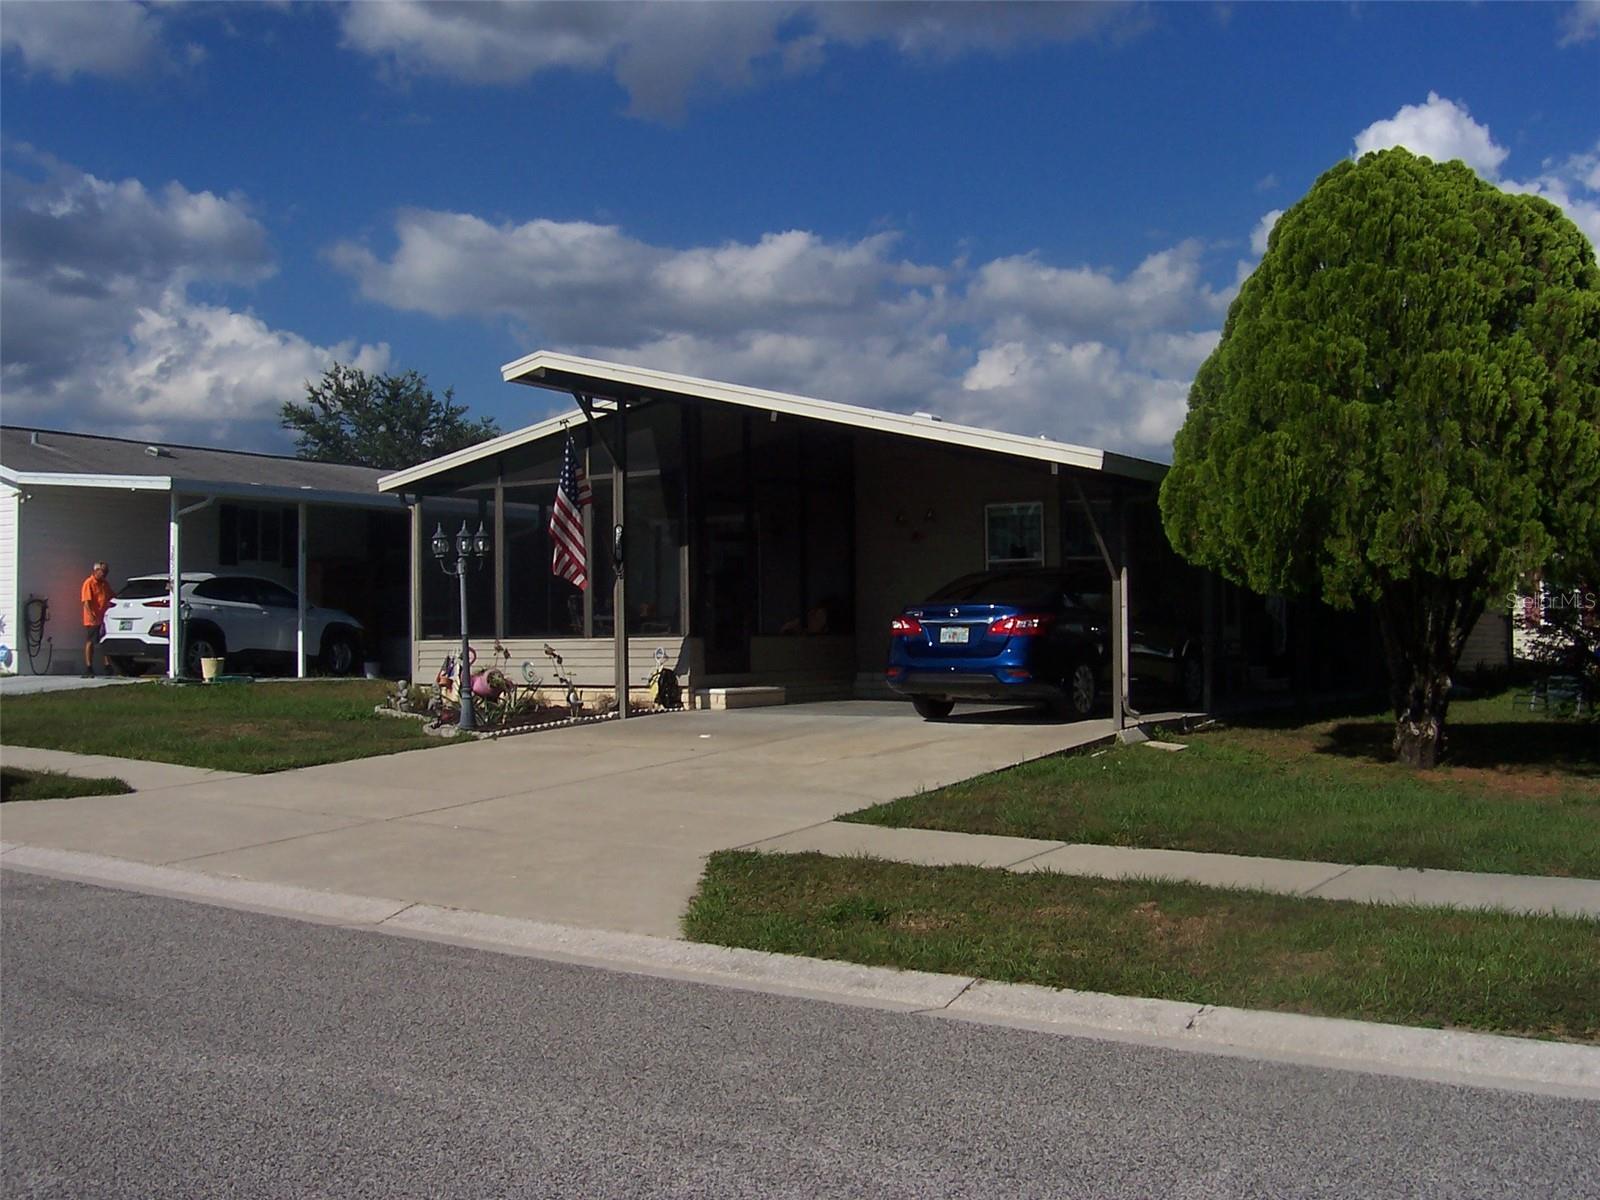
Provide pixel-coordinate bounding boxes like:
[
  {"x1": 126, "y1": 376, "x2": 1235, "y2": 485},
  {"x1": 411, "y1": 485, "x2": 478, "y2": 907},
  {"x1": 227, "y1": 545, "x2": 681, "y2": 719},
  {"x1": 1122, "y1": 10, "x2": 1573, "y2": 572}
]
[{"x1": 0, "y1": 680, "x2": 450, "y2": 773}]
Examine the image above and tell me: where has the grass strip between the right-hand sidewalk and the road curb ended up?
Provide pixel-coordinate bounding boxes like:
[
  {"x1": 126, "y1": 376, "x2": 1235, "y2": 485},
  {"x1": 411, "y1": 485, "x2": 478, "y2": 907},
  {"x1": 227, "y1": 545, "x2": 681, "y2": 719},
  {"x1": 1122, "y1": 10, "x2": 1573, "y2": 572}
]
[{"x1": 683, "y1": 851, "x2": 1600, "y2": 1042}]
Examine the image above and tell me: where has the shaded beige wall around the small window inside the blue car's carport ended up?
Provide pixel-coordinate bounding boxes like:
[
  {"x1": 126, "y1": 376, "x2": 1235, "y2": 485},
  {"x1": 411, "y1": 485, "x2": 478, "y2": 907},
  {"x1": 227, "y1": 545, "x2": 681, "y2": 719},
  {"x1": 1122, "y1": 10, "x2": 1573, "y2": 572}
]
[{"x1": 854, "y1": 435, "x2": 1061, "y2": 694}]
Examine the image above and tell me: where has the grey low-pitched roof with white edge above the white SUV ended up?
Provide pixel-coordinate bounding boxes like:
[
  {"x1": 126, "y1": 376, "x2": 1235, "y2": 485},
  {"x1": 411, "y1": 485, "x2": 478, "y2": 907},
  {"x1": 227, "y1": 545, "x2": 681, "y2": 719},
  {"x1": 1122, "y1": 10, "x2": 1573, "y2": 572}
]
[{"x1": 0, "y1": 426, "x2": 398, "y2": 509}]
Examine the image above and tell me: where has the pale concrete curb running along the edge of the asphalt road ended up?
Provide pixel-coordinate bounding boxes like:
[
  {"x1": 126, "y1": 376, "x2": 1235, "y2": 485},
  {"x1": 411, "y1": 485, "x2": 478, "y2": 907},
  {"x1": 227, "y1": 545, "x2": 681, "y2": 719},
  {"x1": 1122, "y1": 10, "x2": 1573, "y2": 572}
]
[{"x1": 0, "y1": 843, "x2": 1600, "y2": 1099}]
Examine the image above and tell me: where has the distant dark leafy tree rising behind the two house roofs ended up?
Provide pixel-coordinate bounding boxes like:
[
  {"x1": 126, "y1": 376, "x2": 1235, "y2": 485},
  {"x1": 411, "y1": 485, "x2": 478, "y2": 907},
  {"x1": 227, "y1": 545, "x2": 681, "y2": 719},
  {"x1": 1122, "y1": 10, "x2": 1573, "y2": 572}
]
[{"x1": 283, "y1": 363, "x2": 499, "y2": 469}]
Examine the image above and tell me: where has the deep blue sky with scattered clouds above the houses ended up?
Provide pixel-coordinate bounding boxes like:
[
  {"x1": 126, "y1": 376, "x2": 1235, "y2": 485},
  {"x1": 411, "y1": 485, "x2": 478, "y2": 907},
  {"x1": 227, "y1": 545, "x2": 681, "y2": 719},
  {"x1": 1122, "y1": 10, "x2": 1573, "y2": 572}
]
[{"x1": 0, "y1": 0, "x2": 1600, "y2": 459}]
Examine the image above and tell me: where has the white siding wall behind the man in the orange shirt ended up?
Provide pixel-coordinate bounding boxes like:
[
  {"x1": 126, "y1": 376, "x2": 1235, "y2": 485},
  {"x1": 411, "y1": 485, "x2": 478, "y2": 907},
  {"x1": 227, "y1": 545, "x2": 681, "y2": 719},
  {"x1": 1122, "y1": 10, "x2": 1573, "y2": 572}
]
[{"x1": 16, "y1": 486, "x2": 166, "y2": 675}]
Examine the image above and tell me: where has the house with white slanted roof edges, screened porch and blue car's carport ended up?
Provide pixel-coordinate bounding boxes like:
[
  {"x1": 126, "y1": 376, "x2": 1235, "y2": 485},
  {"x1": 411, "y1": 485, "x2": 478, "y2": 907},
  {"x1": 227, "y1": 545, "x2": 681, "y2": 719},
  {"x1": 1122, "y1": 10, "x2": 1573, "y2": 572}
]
[{"x1": 379, "y1": 352, "x2": 1381, "y2": 706}]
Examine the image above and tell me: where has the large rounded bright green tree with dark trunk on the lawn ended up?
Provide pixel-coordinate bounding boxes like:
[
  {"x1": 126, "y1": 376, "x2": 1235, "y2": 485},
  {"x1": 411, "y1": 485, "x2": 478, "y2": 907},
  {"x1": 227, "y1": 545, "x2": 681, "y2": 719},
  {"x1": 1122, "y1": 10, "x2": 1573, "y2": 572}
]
[{"x1": 1162, "y1": 149, "x2": 1600, "y2": 766}]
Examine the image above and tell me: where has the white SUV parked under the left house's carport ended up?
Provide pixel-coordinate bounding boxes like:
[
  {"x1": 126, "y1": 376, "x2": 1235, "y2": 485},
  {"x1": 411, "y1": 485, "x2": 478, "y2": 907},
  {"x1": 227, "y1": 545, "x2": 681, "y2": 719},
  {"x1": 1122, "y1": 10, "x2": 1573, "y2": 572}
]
[{"x1": 101, "y1": 571, "x2": 362, "y2": 675}]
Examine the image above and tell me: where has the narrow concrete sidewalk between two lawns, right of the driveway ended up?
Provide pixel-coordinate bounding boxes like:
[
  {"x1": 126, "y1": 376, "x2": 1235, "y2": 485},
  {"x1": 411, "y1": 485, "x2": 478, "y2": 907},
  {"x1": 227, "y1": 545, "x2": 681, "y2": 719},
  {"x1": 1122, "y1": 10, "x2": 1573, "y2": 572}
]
[{"x1": 746, "y1": 821, "x2": 1600, "y2": 918}]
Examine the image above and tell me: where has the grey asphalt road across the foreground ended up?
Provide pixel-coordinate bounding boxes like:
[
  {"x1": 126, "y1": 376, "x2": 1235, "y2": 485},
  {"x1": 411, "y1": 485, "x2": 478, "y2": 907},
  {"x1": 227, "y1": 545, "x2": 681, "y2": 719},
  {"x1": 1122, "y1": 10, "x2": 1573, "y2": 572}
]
[{"x1": 9, "y1": 872, "x2": 1600, "y2": 1200}]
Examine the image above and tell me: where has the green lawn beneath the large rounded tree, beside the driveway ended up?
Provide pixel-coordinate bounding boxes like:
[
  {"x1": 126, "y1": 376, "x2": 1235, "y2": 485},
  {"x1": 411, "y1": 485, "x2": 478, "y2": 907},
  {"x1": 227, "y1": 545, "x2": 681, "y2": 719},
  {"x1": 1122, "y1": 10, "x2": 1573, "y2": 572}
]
[{"x1": 840, "y1": 694, "x2": 1600, "y2": 878}]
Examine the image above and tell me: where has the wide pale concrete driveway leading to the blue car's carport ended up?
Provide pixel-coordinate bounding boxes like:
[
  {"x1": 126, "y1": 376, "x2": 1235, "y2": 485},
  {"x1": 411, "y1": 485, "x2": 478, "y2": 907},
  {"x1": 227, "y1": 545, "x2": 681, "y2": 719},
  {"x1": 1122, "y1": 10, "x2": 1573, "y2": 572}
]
[{"x1": 3, "y1": 701, "x2": 1110, "y2": 936}]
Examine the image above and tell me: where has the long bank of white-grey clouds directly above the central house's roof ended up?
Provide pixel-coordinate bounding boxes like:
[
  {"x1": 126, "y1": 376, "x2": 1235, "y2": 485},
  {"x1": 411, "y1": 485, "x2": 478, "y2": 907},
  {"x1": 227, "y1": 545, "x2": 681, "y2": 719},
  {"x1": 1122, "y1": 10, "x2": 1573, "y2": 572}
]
[{"x1": 331, "y1": 210, "x2": 1219, "y2": 456}]
